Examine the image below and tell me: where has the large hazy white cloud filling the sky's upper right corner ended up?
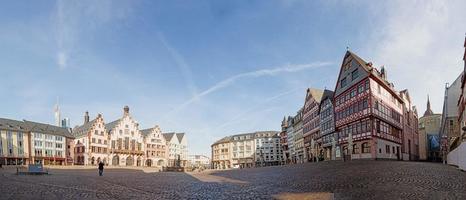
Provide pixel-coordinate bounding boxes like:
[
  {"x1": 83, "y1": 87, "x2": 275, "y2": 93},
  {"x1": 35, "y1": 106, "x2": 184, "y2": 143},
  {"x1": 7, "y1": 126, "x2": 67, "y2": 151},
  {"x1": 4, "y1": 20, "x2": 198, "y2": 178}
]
[{"x1": 363, "y1": 0, "x2": 466, "y2": 115}]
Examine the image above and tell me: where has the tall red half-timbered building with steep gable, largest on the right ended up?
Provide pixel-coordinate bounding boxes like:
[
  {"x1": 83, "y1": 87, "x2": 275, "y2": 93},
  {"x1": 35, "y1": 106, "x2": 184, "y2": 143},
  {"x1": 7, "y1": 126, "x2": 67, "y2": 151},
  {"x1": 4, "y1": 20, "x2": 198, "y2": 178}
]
[{"x1": 333, "y1": 51, "x2": 403, "y2": 159}]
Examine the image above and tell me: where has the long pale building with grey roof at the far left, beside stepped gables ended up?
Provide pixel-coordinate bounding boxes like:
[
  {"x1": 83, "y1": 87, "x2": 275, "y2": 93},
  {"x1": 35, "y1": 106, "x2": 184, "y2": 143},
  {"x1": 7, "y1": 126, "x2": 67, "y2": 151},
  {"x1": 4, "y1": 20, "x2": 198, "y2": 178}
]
[{"x1": 0, "y1": 118, "x2": 74, "y2": 165}]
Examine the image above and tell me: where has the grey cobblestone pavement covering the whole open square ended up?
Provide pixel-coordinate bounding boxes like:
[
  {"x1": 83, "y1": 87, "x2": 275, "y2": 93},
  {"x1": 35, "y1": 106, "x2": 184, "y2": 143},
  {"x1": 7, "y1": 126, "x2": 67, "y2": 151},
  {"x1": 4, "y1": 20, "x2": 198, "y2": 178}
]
[{"x1": 0, "y1": 161, "x2": 466, "y2": 199}]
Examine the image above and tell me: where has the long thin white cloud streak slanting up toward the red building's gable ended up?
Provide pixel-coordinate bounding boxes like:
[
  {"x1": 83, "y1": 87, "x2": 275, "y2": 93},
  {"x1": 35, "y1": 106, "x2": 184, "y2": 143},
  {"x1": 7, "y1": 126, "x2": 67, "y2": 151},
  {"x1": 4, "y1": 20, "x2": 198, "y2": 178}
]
[{"x1": 164, "y1": 62, "x2": 332, "y2": 115}]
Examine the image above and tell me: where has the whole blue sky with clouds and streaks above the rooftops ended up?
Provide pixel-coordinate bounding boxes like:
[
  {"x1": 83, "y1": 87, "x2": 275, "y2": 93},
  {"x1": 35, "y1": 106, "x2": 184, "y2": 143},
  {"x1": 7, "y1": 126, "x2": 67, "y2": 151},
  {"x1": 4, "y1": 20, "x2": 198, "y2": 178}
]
[{"x1": 0, "y1": 0, "x2": 466, "y2": 155}]
